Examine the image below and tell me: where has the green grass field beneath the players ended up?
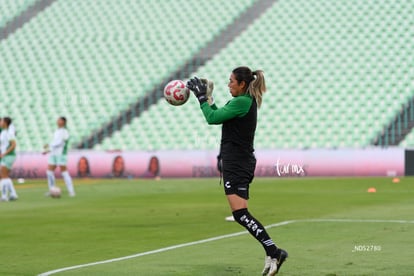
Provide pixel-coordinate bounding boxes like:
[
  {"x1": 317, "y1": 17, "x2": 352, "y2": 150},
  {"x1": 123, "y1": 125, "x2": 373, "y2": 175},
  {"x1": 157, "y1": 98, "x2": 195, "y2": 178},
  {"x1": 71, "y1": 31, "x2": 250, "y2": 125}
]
[{"x1": 0, "y1": 178, "x2": 414, "y2": 275}]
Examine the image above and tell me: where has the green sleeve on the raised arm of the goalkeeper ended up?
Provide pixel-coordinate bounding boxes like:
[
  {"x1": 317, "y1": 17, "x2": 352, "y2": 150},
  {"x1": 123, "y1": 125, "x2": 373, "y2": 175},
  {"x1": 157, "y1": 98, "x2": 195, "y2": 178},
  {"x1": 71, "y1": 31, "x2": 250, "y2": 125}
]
[{"x1": 201, "y1": 96, "x2": 252, "y2": 125}]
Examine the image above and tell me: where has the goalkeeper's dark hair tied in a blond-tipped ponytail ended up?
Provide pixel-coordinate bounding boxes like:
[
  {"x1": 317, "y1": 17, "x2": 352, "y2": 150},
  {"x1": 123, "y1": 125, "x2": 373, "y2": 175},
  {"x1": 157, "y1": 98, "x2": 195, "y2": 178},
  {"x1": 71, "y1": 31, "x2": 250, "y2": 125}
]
[{"x1": 232, "y1": 66, "x2": 266, "y2": 107}]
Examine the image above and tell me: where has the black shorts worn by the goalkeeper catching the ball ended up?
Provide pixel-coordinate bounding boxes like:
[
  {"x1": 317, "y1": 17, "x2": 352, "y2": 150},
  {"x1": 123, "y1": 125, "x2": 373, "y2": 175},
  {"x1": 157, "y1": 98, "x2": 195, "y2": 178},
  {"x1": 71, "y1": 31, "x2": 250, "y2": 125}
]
[{"x1": 223, "y1": 160, "x2": 256, "y2": 199}]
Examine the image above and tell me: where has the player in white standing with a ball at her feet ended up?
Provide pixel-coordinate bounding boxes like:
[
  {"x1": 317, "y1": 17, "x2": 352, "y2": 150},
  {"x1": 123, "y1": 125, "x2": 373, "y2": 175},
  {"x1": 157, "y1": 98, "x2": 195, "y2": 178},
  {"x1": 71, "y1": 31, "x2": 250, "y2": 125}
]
[{"x1": 44, "y1": 117, "x2": 75, "y2": 197}]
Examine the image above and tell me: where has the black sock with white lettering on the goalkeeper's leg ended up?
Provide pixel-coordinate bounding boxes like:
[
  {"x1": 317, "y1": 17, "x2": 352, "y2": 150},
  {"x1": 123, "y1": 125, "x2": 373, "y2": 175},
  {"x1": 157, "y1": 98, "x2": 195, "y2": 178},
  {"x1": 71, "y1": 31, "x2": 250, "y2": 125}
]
[{"x1": 233, "y1": 209, "x2": 277, "y2": 258}]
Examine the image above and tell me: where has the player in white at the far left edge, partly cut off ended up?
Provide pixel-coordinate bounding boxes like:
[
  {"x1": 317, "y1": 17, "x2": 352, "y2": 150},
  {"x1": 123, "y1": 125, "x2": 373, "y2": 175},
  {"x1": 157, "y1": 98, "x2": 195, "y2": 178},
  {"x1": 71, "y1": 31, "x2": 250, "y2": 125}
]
[{"x1": 0, "y1": 117, "x2": 18, "y2": 201}]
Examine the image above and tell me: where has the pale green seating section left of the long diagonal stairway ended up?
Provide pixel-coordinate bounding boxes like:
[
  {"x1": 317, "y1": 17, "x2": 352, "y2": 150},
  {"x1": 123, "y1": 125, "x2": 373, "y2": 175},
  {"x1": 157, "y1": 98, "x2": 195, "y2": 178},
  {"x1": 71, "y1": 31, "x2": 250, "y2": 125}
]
[{"x1": 0, "y1": 0, "x2": 254, "y2": 150}]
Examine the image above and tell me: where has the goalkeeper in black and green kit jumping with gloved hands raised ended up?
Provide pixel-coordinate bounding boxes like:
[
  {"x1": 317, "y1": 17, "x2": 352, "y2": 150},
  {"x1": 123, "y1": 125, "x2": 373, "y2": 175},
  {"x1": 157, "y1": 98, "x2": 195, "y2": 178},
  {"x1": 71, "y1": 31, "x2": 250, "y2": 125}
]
[{"x1": 187, "y1": 67, "x2": 288, "y2": 275}]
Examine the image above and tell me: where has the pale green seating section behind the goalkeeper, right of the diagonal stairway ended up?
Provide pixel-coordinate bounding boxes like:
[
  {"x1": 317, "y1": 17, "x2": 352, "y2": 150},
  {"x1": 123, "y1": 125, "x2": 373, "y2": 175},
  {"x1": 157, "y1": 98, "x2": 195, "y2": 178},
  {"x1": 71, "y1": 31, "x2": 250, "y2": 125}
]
[{"x1": 95, "y1": 0, "x2": 414, "y2": 149}]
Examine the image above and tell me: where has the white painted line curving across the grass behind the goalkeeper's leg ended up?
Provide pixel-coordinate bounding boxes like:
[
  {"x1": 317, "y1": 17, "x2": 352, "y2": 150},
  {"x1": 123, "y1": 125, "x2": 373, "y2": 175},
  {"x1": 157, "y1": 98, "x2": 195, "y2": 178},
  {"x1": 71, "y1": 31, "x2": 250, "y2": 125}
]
[{"x1": 38, "y1": 219, "x2": 414, "y2": 276}]
